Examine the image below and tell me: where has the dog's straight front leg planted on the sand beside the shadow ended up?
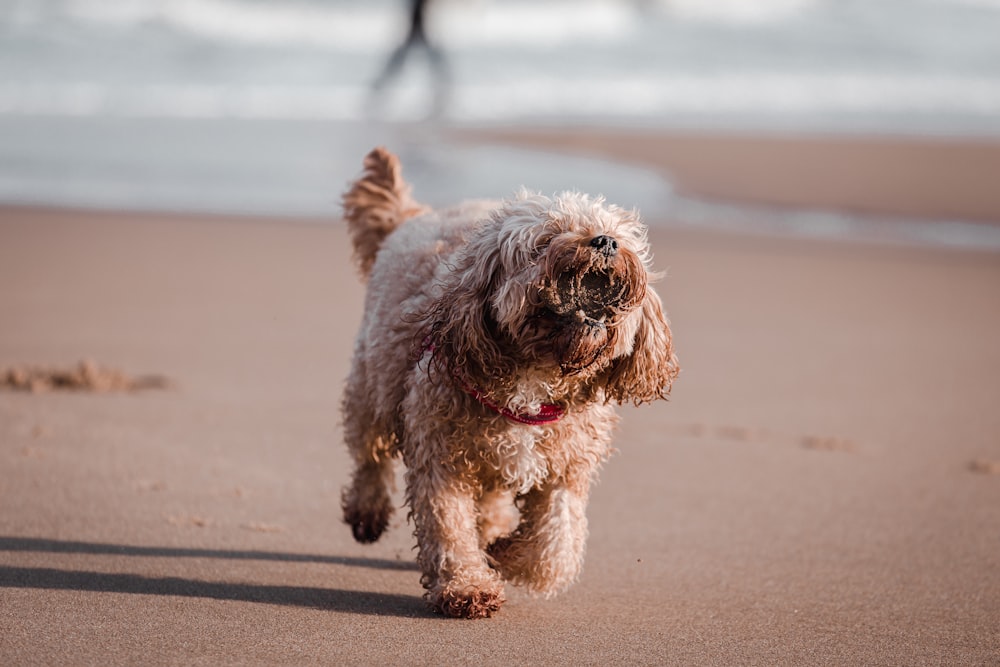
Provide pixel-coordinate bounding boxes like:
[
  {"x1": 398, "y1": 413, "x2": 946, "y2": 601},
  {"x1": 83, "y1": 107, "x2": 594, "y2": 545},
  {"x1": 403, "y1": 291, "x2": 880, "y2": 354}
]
[{"x1": 406, "y1": 463, "x2": 505, "y2": 618}]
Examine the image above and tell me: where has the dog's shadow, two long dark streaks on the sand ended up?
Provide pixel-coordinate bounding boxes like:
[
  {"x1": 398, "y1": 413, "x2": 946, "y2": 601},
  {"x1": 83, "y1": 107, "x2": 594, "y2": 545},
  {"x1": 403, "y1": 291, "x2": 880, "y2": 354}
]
[{"x1": 0, "y1": 537, "x2": 428, "y2": 617}]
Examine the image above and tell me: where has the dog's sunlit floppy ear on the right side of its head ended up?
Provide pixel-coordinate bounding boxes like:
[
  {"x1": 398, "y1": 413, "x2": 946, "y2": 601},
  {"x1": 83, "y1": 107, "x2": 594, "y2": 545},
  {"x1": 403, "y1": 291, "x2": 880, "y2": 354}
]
[{"x1": 605, "y1": 288, "x2": 680, "y2": 405}]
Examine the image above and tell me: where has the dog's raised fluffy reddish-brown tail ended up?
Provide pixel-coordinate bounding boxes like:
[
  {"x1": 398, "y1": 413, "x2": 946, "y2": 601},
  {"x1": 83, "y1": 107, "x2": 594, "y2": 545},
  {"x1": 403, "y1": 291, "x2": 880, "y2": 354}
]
[{"x1": 343, "y1": 146, "x2": 429, "y2": 278}]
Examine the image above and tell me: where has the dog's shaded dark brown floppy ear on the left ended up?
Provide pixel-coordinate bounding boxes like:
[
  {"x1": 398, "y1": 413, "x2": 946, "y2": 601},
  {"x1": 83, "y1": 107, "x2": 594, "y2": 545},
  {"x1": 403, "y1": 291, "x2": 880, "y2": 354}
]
[{"x1": 419, "y1": 219, "x2": 514, "y2": 387}]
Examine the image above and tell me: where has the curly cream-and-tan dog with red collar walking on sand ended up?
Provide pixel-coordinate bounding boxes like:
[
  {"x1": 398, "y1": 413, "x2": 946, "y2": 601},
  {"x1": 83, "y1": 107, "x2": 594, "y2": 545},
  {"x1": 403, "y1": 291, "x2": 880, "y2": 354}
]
[{"x1": 342, "y1": 148, "x2": 679, "y2": 618}]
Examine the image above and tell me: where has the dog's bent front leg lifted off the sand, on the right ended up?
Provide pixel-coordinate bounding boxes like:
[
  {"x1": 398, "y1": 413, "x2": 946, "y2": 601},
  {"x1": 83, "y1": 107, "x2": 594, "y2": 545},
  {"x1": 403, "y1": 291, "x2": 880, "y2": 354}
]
[{"x1": 489, "y1": 479, "x2": 589, "y2": 596}]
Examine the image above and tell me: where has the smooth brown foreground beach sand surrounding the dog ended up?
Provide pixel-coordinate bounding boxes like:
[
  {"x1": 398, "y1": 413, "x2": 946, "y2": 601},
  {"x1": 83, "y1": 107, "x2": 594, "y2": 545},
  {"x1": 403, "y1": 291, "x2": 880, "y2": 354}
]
[{"x1": 0, "y1": 137, "x2": 1000, "y2": 665}]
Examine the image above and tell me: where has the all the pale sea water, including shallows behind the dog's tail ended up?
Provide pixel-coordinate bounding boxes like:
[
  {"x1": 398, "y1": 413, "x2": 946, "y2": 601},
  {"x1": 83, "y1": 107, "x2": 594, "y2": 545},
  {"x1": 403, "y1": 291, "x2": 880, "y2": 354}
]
[{"x1": 0, "y1": 0, "x2": 1000, "y2": 244}]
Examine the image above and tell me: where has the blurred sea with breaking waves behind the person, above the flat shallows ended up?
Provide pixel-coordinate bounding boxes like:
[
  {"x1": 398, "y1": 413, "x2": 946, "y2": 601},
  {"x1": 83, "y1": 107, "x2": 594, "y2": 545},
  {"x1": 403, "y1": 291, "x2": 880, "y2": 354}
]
[{"x1": 0, "y1": 0, "x2": 1000, "y2": 133}]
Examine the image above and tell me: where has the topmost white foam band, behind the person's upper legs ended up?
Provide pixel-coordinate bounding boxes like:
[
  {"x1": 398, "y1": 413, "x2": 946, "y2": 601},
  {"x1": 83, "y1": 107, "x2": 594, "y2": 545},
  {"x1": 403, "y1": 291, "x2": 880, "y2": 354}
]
[{"x1": 58, "y1": 0, "x2": 637, "y2": 53}]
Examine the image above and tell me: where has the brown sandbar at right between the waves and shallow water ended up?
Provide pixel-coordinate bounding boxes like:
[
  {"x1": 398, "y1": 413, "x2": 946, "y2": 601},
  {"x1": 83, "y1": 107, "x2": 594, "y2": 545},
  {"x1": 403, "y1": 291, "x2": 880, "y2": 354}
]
[{"x1": 448, "y1": 126, "x2": 1000, "y2": 226}]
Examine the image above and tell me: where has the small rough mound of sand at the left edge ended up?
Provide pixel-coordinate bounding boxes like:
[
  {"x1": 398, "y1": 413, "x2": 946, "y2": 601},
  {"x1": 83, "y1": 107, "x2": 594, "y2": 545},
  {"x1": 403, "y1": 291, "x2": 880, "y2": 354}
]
[{"x1": 0, "y1": 360, "x2": 170, "y2": 393}]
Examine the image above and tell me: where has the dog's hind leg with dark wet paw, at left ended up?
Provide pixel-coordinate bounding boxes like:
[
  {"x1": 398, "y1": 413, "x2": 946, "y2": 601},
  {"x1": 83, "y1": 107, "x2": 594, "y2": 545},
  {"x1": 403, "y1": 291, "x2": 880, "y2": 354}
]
[{"x1": 341, "y1": 363, "x2": 394, "y2": 543}]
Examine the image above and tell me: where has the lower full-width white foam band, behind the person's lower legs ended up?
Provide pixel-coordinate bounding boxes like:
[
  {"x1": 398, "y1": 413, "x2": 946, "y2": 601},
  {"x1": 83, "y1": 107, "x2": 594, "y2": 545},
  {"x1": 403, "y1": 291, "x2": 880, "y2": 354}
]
[{"x1": 0, "y1": 73, "x2": 1000, "y2": 122}]
